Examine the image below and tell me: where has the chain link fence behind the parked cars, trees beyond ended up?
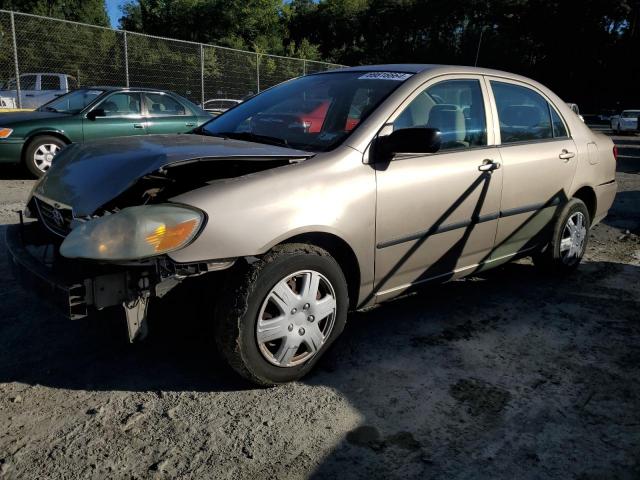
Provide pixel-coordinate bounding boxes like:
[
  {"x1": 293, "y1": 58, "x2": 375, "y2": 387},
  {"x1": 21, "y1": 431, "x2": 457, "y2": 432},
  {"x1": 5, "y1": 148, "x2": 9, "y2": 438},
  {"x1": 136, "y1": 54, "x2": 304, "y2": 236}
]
[{"x1": 0, "y1": 10, "x2": 341, "y2": 108}]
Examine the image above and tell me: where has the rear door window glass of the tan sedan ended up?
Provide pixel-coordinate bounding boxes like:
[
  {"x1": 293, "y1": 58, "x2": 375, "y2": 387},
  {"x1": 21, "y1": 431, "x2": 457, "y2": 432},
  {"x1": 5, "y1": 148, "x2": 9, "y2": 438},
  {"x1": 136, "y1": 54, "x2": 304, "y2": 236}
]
[{"x1": 491, "y1": 80, "x2": 566, "y2": 144}]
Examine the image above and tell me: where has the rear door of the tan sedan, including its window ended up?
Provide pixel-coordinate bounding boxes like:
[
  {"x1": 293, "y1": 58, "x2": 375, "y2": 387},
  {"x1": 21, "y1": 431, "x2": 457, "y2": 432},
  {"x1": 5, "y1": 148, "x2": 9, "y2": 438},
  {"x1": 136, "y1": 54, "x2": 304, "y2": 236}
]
[{"x1": 487, "y1": 77, "x2": 577, "y2": 261}]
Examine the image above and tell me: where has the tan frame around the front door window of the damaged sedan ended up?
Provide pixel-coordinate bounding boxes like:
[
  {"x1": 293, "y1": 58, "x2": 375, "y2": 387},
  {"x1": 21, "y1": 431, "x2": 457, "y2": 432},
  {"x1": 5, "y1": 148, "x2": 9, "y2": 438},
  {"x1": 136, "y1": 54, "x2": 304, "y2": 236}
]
[{"x1": 366, "y1": 73, "x2": 499, "y2": 163}]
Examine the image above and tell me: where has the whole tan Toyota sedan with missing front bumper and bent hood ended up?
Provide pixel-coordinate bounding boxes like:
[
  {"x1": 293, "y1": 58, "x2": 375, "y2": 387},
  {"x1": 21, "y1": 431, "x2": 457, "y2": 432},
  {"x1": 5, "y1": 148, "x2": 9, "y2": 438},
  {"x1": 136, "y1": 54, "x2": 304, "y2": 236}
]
[{"x1": 7, "y1": 65, "x2": 616, "y2": 385}]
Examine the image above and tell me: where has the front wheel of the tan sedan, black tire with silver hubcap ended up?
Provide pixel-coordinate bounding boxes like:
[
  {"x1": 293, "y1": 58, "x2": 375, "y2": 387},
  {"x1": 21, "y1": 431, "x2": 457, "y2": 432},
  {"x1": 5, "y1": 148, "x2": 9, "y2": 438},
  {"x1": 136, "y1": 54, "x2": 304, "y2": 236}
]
[{"x1": 215, "y1": 244, "x2": 349, "y2": 386}]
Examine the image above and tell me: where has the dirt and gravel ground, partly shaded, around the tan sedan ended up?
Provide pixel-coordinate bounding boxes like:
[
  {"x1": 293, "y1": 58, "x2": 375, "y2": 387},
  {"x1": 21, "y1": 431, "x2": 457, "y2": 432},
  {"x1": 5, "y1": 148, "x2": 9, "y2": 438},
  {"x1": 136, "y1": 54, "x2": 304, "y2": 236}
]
[{"x1": 0, "y1": 129, "x2": 640, "y2": 480}]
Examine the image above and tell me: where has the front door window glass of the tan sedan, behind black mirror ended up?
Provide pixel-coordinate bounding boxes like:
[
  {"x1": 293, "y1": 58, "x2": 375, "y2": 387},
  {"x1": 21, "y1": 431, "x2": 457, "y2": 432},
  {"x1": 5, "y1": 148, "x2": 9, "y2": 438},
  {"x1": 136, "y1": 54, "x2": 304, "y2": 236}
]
[{"x1": 393, "y1": 80, "x2": 487, "y2": 150}]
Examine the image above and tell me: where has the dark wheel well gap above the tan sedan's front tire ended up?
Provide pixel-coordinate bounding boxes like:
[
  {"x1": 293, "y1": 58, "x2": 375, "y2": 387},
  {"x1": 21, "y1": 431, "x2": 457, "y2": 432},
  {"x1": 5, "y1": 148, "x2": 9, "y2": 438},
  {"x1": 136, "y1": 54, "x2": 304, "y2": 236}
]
[{"x1": 281, "y1": 232, "x2": 360, "y2": 309}]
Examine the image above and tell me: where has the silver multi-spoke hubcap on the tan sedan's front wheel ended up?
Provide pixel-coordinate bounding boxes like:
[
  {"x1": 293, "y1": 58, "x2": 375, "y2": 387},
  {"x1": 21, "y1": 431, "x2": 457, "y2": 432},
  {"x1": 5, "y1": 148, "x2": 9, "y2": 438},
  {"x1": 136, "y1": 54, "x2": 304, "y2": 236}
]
[{"x1": 256, "y1": 270, "x2": 336, "y2": 367}]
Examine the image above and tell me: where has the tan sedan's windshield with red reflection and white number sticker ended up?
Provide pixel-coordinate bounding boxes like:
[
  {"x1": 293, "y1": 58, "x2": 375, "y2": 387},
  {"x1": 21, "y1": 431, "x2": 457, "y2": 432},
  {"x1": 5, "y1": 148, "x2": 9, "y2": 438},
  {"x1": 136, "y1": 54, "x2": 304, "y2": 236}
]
[{"x1": 202, "y1": 72, "x2": 411, "y2": 151}]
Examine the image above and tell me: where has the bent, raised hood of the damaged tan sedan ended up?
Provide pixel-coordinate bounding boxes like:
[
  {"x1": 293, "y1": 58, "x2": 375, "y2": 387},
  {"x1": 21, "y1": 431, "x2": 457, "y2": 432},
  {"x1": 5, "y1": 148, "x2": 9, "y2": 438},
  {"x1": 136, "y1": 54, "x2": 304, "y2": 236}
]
[{"x1": 33, "y1": 134, "x2": 313, "y2": 217}]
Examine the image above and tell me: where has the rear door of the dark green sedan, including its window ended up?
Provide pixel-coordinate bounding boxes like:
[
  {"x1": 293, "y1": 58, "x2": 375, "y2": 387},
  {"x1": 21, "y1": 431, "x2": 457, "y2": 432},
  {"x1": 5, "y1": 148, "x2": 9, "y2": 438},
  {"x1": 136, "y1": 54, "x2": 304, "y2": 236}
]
[{"x1": 142, "y1": 92, "x2": 198, "y2": 134}]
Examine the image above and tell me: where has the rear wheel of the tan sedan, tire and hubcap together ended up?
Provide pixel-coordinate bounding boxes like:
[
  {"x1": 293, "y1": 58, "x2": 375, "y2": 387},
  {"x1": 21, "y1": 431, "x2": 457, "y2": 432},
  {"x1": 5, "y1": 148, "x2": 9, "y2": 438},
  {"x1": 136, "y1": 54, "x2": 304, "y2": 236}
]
[{"x1": 533, "y1": 198, "x2": 591, "y2": 274}]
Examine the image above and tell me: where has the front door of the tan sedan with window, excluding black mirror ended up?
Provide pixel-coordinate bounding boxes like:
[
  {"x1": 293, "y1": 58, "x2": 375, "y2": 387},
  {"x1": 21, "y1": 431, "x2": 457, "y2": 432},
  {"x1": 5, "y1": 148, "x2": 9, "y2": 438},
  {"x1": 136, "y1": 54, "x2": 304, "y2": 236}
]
[{"x1": 375, "y1": 75, "x2": 502, "y2": 301}]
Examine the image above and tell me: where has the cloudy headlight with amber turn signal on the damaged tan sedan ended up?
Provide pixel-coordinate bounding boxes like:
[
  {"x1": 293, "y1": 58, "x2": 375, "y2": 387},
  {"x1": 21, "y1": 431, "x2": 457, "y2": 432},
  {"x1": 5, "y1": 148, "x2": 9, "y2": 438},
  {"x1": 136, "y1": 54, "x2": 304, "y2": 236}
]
[{"x1": 60, "y1": 204, "x2": 204, "y2": 260}]
